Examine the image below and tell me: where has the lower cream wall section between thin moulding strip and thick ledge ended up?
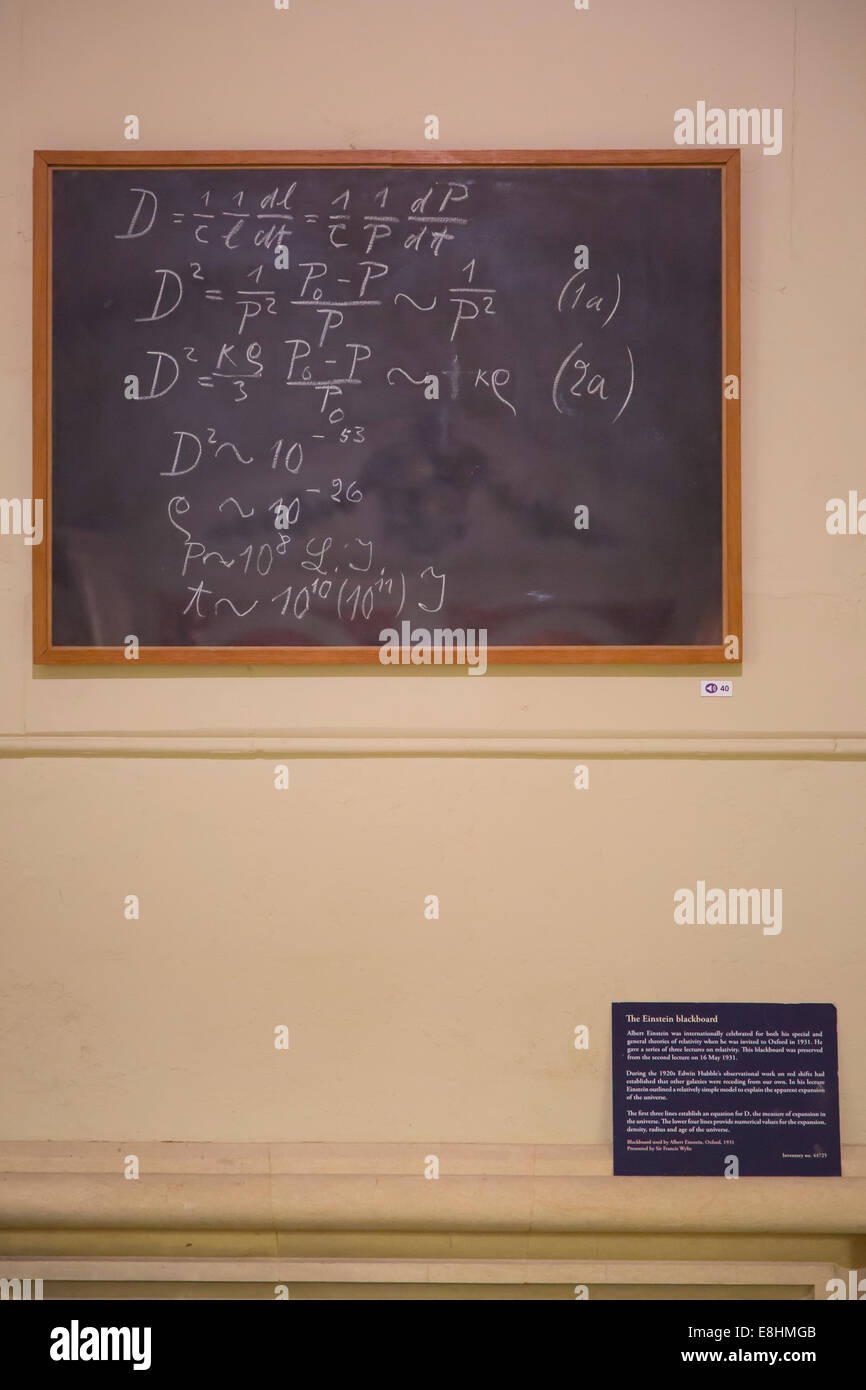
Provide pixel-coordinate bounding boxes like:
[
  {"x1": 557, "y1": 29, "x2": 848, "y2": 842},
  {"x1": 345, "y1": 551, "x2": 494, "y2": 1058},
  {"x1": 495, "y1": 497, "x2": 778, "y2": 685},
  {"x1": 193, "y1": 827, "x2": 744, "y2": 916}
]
[{"x1": 3, "y1": 758, "x2": 866, "y2": 1144}]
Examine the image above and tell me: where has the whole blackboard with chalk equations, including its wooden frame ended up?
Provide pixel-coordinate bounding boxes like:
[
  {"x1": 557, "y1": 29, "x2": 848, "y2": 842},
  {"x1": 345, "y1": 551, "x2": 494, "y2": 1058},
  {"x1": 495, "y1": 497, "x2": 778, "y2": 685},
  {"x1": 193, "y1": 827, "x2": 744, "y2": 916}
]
[{"x1": 33, "y1": 150, "x2": 741, "y2": 662}]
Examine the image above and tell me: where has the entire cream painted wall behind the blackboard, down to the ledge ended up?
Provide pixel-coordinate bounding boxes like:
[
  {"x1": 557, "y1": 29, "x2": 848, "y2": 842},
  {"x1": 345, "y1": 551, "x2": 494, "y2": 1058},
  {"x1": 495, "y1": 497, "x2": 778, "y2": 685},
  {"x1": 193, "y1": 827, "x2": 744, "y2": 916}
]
[{"x1": 0, "y1": 0, "x2": 866, "y2": 1144}]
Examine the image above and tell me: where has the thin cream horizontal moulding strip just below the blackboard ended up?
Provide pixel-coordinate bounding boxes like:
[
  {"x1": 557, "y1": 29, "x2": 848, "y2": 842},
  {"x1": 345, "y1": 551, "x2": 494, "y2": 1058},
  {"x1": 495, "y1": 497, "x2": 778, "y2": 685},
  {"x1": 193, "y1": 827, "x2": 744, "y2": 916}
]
[{"x1": 0, "y1": 731, "x2": 866, "y2": 762}]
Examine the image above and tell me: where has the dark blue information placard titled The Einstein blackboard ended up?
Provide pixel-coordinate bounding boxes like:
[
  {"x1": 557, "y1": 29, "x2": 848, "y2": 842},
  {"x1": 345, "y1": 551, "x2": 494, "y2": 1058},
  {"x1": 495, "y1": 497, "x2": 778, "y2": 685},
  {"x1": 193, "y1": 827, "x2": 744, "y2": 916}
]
[{"x1": 612, "y1": 1004, "x2": 841, "y2": 1177}]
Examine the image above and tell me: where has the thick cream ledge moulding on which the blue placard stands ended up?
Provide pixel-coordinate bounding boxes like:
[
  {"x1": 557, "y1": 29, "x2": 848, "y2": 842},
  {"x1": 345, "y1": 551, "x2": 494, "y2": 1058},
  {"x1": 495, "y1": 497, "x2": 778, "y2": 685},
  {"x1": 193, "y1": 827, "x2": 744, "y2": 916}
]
[{"x1": 0, "y1": 1140, "x2": 866, "y2": 1234}]
